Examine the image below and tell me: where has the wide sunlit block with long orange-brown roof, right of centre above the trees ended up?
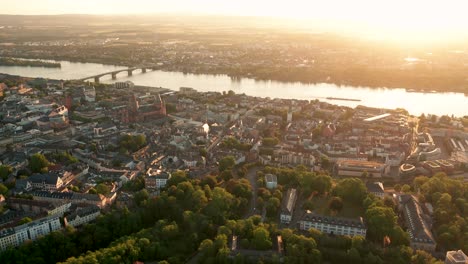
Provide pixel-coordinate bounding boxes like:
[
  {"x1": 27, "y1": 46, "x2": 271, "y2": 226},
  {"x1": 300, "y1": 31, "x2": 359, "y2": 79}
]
[{"x1": 337, "y1": 160, "x2": 387, "y2": 178}]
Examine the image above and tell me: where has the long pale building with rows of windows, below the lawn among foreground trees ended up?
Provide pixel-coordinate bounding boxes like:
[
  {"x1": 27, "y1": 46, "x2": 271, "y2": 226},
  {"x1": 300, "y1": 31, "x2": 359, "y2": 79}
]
[{"x1": 299, "y1": 210, "x2": 367, "y2": 237}]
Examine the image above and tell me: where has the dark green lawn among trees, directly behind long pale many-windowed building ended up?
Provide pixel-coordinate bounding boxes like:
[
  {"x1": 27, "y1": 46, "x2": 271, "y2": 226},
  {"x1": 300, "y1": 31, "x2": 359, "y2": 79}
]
[{"x1": 310, "y1": 196, "x2": 364, "y2": 218}]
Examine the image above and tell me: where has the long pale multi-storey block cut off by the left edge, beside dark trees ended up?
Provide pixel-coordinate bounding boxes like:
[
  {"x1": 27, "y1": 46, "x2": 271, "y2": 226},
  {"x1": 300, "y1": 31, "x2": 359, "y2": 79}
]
[{"x1": 0, "y1": 216, "x2": 62, "y2": 251}]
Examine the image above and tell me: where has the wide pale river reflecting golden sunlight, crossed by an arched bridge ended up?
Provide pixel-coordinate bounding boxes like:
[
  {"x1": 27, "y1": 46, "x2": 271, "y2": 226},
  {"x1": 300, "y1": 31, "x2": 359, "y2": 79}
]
[{"x1": 0, "y1": 61, "x2": 468, "y2": 116}]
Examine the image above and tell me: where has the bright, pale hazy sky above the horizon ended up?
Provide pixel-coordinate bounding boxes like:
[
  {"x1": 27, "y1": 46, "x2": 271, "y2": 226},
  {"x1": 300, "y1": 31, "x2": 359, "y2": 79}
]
[{"x1": 0, "y1": 0, "x2": 468, "y2": 42}]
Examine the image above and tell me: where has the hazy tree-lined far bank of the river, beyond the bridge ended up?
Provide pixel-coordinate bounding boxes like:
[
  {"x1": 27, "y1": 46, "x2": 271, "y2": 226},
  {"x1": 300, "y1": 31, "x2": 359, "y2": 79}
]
[{"x1": 4, "y1": 56, "x2": 468, "y2": 95}]
